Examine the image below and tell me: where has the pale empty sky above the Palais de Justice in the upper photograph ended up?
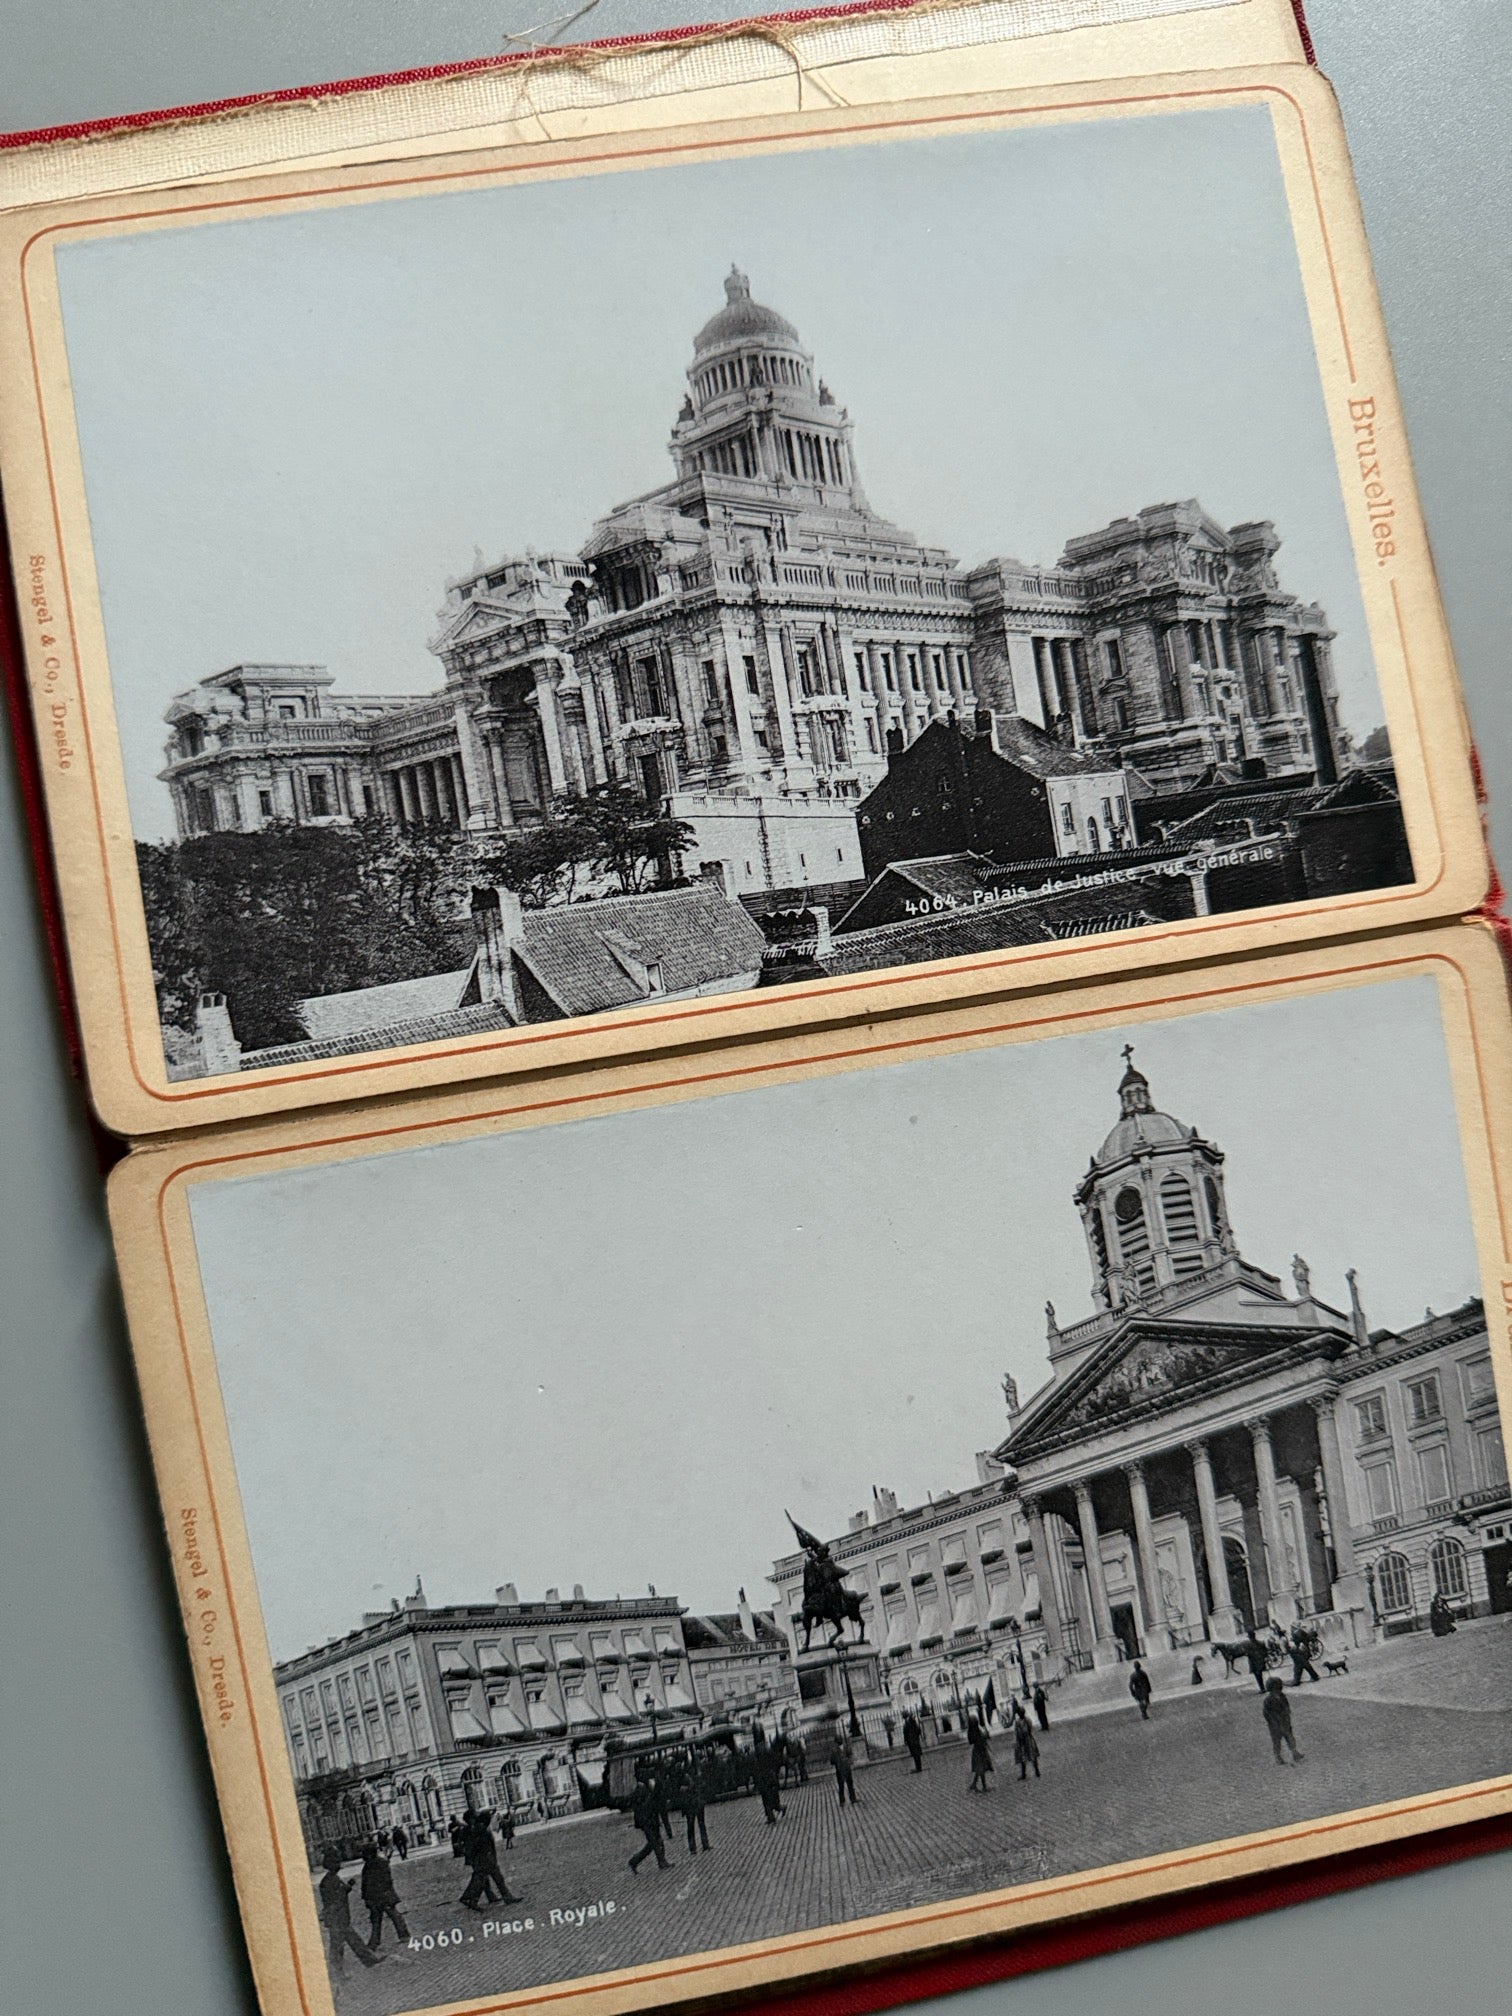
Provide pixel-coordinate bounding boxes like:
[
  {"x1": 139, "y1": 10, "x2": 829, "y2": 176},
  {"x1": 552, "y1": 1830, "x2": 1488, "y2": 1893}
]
[{"x1": 58, "y1": 109, "x2": 1381, "y2": 839}]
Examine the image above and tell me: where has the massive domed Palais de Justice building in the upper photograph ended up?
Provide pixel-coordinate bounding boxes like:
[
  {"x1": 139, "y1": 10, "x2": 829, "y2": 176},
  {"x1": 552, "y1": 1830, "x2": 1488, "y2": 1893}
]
[{"x1": 161, "y1": 270, "x2": 1349, "y2": 895}]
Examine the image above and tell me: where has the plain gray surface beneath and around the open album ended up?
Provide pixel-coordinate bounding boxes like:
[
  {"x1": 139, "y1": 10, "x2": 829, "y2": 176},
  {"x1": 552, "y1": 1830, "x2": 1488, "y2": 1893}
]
[{"x1": 0, "y1": 0, "x2": 1512, "y2": 2016}]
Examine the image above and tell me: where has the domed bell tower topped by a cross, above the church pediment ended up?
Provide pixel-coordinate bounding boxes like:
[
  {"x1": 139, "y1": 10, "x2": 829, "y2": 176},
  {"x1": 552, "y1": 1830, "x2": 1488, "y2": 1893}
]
[{"x1": 1077, "y1": 1044, "x2": 1238, "y2": 1310}]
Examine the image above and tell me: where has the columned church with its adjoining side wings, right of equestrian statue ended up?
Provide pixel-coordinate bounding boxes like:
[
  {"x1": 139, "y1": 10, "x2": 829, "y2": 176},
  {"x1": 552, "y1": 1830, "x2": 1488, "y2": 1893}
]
[{"x1": 772, "y1": 1050, "x2": 1512, "y2": 1712}]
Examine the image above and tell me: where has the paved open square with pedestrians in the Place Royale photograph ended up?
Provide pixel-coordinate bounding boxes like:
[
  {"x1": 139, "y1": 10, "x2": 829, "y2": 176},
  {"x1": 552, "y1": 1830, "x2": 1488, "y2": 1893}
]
[{"x1": 322, "y1": 1617, "x2": 1512, "y2": 2016}]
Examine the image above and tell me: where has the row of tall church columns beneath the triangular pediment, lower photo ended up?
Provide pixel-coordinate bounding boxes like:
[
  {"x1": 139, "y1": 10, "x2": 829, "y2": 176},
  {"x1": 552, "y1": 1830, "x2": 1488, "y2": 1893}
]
[{"x1": 1024, "y1": 1393, "x2": 1357, "y2": 1665}]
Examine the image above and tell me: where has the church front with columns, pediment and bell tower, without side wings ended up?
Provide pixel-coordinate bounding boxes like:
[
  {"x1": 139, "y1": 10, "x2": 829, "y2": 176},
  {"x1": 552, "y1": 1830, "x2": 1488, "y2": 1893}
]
[{"x1": 996, "y1": 1050, "x2": 1365, "y2": 1671}]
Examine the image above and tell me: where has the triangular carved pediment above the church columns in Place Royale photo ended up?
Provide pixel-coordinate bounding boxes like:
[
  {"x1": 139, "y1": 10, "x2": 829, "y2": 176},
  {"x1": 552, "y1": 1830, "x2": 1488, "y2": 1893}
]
[{"x1": 998, "y1": 1316, "x2": 1349, "y2": 1464}]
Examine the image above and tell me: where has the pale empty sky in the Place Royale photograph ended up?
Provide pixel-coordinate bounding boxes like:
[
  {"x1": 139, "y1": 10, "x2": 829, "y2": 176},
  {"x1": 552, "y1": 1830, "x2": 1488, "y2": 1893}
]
[{"x1": 192, "y1": 980, "x2": 1478, "y2": 1657}]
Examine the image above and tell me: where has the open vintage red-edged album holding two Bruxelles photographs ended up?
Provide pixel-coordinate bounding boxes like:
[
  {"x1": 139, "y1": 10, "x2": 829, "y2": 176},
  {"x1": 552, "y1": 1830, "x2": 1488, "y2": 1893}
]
[{"x1": 0, "y1": 0, "x2": 1512, "y2": 2016}]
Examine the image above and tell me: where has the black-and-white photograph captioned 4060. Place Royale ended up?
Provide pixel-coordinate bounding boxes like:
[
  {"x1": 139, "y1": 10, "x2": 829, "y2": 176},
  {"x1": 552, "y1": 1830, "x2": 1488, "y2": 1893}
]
[{"x1": 190, "y1": 978, "x2": 1512, "y2": 2016}]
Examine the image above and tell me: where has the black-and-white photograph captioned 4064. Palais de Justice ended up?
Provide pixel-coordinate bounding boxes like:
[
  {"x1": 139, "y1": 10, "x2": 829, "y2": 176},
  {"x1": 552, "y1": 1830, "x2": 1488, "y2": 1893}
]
[{"x1": 56, "y1": 105, "x2": 1413, "y2": 1083}]
